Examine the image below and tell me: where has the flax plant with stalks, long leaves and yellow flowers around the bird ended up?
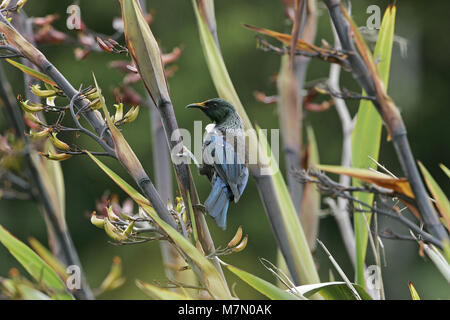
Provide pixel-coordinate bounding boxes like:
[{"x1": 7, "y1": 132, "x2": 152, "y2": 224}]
[{"x1": 0, "y1": 0, "x2": 450, "y2": 300}]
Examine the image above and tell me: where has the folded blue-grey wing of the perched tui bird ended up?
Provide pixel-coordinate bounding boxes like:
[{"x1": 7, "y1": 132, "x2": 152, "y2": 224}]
[{"x1": 206, "y1": 134, "x2": 248, "y2": 202}]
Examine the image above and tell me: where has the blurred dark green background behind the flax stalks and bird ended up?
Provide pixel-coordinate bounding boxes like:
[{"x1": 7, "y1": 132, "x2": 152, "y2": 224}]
[{"x1": 0, "y1": 0, "x2": 450, "y2": 299}]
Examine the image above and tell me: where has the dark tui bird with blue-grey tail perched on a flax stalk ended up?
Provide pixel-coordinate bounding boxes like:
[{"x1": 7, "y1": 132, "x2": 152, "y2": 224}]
[{"x1": 186, "y1": 98, "x2": 248, "y2": 230}]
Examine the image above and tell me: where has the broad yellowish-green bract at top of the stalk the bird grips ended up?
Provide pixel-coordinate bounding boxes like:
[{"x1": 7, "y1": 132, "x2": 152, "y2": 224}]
[{"x1": 119, "y1": 0, "x2": 170, "y2": 106}]
